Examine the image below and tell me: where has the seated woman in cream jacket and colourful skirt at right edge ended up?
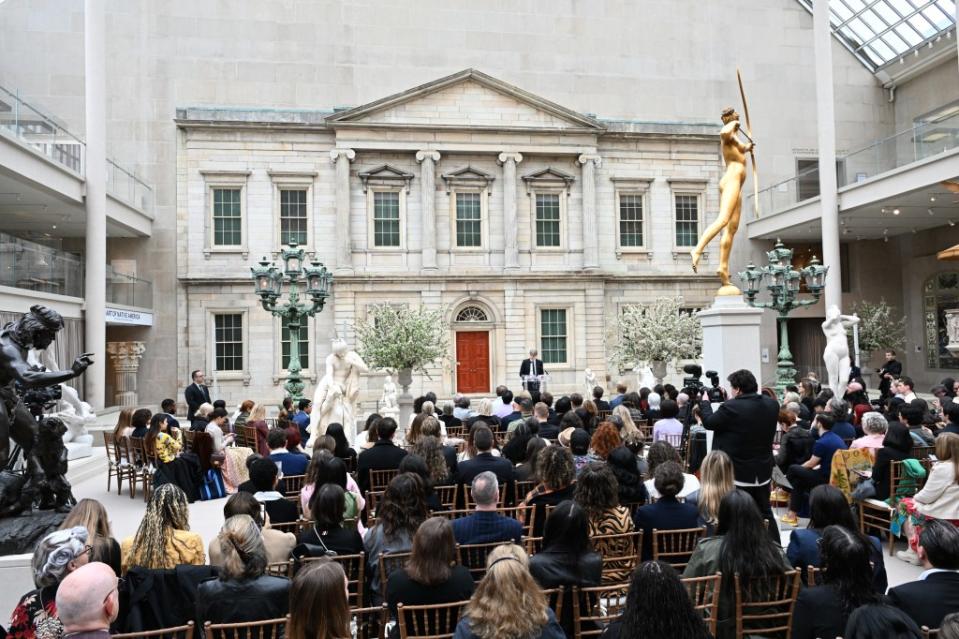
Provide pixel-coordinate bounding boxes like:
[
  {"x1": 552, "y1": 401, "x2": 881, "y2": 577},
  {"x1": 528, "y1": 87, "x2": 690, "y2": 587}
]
[{"x1": 890, "y1": 433, "x2": 959, "y2": 566}]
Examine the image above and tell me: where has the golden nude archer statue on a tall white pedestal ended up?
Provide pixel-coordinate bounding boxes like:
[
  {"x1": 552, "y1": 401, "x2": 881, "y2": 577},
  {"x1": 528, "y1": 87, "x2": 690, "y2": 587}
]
[{"x1": 692, "y1": 107, "x2": 755, "y2": 295}]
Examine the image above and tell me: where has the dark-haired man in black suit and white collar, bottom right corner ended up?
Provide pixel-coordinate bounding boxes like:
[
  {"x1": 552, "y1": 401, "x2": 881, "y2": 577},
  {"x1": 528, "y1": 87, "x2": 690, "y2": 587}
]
[{"x1": 889, "y1": 519, "x2": 959, "y2": 628}]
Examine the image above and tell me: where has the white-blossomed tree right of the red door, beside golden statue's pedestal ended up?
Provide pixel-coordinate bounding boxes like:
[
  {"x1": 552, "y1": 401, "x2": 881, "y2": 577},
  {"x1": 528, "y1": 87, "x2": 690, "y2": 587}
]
[{"x1": 610, "y1": 298, "x2": 703, "y2": 383}]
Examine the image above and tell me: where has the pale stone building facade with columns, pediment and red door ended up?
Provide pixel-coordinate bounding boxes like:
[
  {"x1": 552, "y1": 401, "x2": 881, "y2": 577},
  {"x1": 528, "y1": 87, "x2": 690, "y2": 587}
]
[{"x1": 177, "y1": 69, "x2": 722, "y2": 402}]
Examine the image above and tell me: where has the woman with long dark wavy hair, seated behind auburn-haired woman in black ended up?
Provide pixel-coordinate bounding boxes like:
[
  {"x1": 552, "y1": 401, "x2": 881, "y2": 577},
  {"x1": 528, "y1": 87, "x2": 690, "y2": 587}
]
[{"x1": 360, "y1": 472, "x2": 428, "y2": 605}]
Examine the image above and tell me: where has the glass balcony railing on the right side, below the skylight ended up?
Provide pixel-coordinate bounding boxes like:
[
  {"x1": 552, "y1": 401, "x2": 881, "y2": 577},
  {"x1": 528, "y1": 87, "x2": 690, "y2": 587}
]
[{"x1": 743, "y1": 112, "x2": 959, "y2": 215}]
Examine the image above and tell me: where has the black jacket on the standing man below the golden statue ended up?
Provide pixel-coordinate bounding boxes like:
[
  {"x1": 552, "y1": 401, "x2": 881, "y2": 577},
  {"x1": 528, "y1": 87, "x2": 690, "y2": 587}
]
[{"x1": 704, "y1": 393, "x2": 779, "y2": 484}]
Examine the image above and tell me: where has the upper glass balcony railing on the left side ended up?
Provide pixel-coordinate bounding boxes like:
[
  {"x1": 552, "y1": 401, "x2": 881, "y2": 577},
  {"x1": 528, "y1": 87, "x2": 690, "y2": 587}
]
[{"x1": 0, "y1": 87, "x2": 154, "y2": 215}]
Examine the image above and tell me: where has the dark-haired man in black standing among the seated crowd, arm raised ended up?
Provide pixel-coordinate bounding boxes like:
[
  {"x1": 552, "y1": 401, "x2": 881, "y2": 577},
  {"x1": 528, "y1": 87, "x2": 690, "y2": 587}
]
[{"x1": 704, "y1": 369, "x2": 779, "y2": 543}]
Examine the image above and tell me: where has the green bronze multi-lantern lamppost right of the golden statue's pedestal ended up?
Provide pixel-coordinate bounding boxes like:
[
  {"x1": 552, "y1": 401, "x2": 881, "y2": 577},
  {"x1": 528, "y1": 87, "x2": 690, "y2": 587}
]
[{"x1": 739, "y1": 239, "x2": 829, "y2": 397}]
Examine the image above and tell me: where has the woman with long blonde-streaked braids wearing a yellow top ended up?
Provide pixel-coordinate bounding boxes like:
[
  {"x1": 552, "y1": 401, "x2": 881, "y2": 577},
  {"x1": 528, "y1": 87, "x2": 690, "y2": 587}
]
[{"x1": 120, "y1": 484, "x2": 206, "y2": 573}]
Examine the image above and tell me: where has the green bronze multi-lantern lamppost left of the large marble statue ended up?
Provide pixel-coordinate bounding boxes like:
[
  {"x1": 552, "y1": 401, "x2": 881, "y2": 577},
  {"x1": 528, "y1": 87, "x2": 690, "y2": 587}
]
[{"x1": 250, "y1": 241, "x2": 333, "y2": 400}]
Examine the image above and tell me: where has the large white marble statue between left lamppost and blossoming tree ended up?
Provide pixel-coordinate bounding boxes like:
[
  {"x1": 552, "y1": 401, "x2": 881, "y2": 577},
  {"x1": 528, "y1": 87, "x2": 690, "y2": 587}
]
[{"x1": 307, "y1": 337, "x2": 370, "y2": 447}]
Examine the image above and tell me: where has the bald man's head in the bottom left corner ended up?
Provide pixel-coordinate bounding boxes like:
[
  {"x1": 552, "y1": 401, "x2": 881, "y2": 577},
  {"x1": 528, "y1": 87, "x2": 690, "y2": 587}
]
[{"x1": 57, "y1": 561, "x2": 120, "y2": 639}]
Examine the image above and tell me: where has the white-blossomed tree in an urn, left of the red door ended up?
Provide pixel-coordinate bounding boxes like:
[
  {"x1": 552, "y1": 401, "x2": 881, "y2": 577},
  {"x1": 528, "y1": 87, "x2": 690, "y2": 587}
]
[{"x1": 356, "y1": 304, "x2": 450, "y2": 427}]
